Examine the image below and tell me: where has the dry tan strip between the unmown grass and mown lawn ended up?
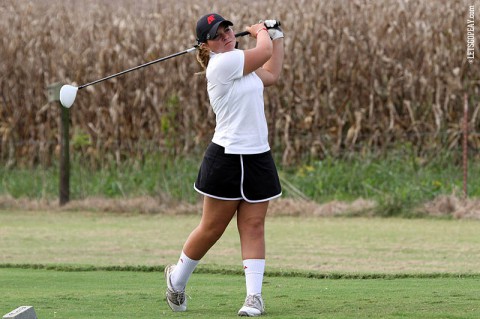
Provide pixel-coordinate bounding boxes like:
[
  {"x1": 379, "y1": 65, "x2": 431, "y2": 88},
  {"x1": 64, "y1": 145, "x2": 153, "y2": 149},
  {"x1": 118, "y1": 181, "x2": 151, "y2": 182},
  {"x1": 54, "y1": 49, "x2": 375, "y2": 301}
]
[{"x1": 0, "y1": 195, "x2": 480, "y2": 219}]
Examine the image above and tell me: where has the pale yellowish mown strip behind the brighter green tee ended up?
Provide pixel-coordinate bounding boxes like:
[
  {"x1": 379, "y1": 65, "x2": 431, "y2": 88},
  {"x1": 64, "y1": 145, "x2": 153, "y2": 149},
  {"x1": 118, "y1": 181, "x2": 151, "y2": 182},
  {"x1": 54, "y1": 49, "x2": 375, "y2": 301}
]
[{"x1": 0, "y1": 211, "x2": 480, "y2": 274}]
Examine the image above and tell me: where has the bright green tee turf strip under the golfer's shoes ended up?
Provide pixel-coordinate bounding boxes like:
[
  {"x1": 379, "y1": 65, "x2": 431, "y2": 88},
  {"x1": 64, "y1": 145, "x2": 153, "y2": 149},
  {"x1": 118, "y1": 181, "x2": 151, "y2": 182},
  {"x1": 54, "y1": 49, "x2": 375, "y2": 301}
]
[{"x1": 0, "y1": 269, "x2": 480, "y2": 319}]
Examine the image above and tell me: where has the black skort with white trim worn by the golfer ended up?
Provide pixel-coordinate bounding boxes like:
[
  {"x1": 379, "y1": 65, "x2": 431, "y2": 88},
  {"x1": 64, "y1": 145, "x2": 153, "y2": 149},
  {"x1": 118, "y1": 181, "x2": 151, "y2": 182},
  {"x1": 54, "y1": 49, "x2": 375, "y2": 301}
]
[{"x1": 194, "y1": 143, "x2": 282, "y2": 203}]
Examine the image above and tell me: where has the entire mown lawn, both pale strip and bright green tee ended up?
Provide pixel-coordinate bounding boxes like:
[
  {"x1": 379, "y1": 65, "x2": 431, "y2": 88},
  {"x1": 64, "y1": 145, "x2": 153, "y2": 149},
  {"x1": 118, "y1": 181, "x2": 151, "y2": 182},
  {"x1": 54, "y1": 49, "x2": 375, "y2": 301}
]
[{"x1": 0, "y1": 211, "x2": 480, "y2": 319}]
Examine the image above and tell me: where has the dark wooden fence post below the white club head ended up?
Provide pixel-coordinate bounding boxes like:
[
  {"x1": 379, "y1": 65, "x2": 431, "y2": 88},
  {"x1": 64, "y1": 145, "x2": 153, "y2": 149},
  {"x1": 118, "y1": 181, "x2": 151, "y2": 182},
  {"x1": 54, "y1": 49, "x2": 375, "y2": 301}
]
[{"x1": 48, "y1": 83, "x2": 70, "y2": 206}]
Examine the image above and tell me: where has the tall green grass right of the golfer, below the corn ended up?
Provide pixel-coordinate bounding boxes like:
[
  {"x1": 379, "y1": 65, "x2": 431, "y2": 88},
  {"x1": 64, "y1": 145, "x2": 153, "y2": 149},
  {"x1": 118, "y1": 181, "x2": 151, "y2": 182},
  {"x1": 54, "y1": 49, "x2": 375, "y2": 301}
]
[{"x1": 290, "y1": 151, "x2": 480, "y2": 216}]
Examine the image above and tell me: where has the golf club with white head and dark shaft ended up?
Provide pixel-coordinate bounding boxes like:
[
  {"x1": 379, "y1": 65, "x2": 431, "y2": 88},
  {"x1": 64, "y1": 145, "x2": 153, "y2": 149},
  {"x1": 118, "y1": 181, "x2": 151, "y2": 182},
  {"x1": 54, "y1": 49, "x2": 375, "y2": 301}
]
[{"x1": 60, "y1": 21, "x2": 281, "y2": 108}]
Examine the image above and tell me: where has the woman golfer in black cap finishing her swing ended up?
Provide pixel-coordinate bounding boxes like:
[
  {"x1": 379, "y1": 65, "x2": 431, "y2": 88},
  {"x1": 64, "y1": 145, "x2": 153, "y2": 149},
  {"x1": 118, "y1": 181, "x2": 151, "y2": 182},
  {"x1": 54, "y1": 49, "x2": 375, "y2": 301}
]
[{"x1": 165, "y1": 13, "x2": 284, "y2": 317}]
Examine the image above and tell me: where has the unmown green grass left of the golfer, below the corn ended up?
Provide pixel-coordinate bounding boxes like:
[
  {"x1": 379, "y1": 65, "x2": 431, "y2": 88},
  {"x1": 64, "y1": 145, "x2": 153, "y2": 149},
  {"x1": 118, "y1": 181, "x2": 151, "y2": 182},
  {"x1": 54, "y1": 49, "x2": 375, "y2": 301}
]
[{"x1": 0, "y1": 155, "x2": 200, "y2": 202}]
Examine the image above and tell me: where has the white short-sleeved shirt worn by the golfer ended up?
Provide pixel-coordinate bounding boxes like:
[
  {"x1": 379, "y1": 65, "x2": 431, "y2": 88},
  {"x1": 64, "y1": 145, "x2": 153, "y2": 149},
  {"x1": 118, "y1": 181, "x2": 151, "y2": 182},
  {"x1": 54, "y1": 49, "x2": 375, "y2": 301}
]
[{"x1": 207, "y1": 50, "x2": 270, "y2": 154}]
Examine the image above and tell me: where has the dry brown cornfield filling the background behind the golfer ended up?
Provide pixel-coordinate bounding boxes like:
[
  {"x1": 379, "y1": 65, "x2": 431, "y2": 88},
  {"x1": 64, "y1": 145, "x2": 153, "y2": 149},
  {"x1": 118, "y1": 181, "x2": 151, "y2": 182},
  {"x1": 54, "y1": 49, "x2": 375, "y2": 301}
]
[{"x1": 0, "y1": 0, "x2": 480, "y2": 165}]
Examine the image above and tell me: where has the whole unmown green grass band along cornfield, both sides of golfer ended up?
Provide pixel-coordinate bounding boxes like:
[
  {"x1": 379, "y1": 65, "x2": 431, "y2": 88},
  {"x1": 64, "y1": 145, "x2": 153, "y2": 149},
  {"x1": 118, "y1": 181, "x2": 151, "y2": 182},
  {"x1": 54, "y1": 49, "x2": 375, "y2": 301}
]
[{"x1": 0, "y1": 150, "x2": 480, "y2": 216}]
